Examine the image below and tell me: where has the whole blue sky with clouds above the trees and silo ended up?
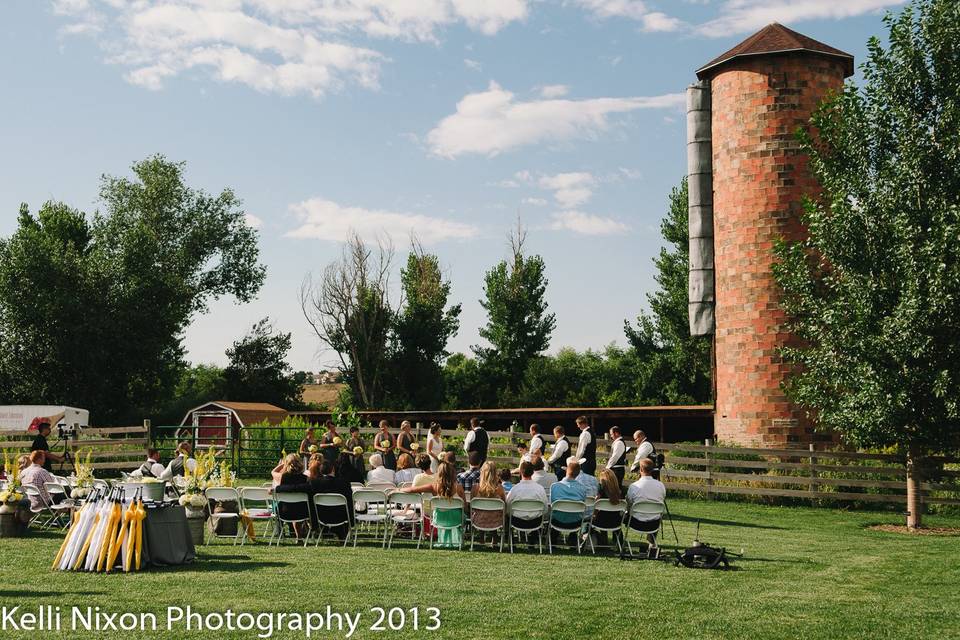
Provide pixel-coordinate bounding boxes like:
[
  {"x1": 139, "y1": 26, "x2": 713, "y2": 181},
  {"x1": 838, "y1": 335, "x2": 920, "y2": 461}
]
[{"x1": 0, "y1": 0, "x2": 901, "y2": 369}]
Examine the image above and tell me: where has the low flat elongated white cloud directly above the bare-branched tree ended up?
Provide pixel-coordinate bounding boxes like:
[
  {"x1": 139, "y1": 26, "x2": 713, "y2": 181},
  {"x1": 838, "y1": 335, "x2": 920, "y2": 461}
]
[{"x1": 286, "y1": 198, "x2": 479, "y2": 244}]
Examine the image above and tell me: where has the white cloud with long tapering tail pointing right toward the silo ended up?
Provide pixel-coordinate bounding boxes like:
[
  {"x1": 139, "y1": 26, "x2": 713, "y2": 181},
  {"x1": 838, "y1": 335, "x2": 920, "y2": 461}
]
[{"x1": 427, "y1": 82, "x2": 685, "y2": 158}]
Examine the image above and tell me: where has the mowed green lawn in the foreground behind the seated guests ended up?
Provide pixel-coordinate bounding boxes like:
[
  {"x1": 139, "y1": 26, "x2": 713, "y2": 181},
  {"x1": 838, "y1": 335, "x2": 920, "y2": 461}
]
[{"x1": 0, "y1": 500, "x2": 960, "y2": 640}]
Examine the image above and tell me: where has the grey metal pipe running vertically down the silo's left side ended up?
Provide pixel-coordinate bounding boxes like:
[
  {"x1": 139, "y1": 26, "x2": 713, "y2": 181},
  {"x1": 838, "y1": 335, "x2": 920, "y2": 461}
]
[{"x1": 687, "y1": 80, "x2": 716, "y2": 336}]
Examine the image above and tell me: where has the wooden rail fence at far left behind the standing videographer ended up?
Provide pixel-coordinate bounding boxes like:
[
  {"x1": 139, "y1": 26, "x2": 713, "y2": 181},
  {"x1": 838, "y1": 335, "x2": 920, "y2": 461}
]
[{"x1": 0, "y1": 424, "x2": 149, "y2": 473}]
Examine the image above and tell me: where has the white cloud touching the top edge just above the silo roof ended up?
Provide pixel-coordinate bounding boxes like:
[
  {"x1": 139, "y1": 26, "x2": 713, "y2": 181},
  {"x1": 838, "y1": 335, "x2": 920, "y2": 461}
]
[{"x1": 697, "y1": 0, "x2": 906, "y2": 38}]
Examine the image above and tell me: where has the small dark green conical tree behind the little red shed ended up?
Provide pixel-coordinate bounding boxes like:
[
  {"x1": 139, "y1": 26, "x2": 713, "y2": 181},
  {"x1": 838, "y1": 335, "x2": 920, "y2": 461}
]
[{"x1": 223, "y1": 318, "x2": 303, "y2": 409}]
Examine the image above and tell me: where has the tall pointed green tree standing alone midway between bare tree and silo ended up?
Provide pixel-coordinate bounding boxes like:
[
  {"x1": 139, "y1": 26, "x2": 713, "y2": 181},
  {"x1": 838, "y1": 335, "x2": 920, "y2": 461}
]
[{"x1": 473, "y1": 229, "x2": 557, "y2": 396}]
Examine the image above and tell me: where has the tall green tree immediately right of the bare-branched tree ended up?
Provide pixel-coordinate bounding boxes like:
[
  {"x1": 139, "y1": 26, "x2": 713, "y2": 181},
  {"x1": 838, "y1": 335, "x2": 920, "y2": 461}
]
[{"x1": 390, "y1": 241, "x2": 460, "y2": 410}]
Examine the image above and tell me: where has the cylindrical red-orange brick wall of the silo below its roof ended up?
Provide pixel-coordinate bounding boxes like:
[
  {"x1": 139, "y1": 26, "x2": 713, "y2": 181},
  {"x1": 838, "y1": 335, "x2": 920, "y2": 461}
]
[{"x1": 712, "y1": 54, "x2": 844, "y2": 447}]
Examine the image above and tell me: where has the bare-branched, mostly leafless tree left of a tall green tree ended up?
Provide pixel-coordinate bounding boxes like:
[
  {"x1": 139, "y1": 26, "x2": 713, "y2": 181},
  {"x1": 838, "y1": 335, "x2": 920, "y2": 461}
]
[{"x1": 300, "y1": 233, "x2": 395, "y2": 408}]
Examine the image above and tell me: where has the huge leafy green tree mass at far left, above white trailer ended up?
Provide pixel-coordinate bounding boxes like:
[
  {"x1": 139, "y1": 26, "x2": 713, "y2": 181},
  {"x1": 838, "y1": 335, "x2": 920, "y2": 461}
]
[{"x1": 0, "y1": 156, "x2": 264, "y2": 424}]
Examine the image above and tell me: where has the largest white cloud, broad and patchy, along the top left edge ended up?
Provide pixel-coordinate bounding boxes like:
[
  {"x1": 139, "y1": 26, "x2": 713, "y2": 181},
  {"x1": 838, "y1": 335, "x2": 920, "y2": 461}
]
[{"x1": 53, "y1": 0, "x2": 528, "y2": 98}]
